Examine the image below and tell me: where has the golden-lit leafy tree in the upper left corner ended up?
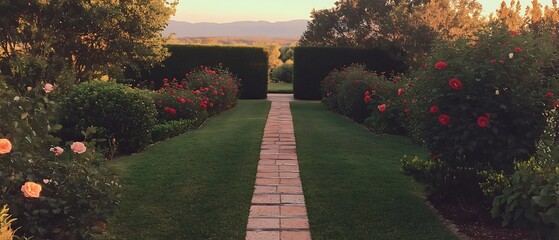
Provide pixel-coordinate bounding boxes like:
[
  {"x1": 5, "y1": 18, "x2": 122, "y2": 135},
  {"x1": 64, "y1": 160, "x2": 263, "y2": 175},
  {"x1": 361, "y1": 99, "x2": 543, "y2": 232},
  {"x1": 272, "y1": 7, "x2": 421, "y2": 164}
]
[{"x1": 0, "y1": 0, "x2": 177, "y2": 86}]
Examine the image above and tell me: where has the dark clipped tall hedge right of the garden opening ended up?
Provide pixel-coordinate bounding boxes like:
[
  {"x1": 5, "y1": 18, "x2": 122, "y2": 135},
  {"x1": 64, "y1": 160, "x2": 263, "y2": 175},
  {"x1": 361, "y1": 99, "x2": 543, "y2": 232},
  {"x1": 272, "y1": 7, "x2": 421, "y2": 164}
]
[{"x1": 293, "y1": 47, "x2": 406, "y2": 100}]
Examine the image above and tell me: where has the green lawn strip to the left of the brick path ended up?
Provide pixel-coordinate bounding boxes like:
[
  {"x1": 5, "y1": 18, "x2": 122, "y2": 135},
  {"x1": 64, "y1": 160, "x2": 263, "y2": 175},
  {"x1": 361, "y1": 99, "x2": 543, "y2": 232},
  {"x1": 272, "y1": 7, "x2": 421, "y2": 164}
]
[{"x1": 105, "y1": 100, "x2": 270, "y2": 240}]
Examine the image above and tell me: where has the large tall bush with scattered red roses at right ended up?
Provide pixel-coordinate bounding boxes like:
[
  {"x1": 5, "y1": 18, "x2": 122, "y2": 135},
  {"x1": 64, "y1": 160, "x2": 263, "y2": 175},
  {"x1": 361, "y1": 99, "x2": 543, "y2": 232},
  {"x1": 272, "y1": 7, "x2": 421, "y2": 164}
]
[{"x1": 404, "y1": 25, "x2": 554, "y2": 203}]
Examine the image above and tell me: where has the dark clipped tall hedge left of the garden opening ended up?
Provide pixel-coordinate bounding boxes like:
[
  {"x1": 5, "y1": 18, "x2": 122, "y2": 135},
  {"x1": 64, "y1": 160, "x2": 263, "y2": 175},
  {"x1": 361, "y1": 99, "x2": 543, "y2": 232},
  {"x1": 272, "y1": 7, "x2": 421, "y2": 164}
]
[{"x1": 135, "y1": 45, "x2": 268, "y2": 99}]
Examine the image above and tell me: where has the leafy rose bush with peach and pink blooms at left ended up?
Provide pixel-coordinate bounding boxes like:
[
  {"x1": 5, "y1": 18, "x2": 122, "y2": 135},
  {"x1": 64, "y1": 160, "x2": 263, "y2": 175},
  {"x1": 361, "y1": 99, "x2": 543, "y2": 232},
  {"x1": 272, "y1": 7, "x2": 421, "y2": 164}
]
[{"x1": 0, "y1": 81, "x2": 119, "y2": 239}]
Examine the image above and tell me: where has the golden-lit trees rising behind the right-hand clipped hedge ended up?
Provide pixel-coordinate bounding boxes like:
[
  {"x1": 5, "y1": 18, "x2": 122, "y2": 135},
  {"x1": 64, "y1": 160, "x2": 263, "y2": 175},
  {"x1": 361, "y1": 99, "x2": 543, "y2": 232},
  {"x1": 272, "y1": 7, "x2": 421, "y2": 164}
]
[{"x1": 299, "y1": 0, "x2": 483, "y2": 66}]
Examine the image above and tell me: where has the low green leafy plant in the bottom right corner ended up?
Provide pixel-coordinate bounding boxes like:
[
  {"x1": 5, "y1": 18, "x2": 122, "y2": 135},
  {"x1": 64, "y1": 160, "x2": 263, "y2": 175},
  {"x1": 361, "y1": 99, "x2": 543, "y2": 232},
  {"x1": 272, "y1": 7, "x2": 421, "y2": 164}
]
[{"x1": 491, "y1": 109, "x2": 559, "y2": 239}]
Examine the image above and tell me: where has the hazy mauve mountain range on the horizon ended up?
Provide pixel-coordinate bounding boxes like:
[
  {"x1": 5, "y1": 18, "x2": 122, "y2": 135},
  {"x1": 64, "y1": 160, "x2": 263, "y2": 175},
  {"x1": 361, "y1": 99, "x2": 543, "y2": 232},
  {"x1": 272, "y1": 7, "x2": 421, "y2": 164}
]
[{"x1": 163, "y1": 20, "x2": 307, "y2": 38}]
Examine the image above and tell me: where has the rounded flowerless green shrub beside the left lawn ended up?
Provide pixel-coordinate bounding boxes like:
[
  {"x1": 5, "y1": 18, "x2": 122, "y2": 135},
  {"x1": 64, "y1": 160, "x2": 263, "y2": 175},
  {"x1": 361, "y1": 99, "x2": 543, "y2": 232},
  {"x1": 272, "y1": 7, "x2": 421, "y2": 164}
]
[{"x1": 61, "y1": 82, "x2": 157, "y2": 153}]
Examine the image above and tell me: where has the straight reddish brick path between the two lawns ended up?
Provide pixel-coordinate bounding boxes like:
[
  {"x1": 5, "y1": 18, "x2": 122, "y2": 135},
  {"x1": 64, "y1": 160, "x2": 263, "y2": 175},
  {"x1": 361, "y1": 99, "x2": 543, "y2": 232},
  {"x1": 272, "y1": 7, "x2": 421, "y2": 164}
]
[{"x1": 246, "y1": 94, "x2": 311, "y2": 240}]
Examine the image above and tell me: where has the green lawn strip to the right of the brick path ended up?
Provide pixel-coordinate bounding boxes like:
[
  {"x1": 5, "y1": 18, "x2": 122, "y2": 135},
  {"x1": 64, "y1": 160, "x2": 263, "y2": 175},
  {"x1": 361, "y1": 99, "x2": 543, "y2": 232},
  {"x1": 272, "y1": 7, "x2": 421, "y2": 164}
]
[{"x1": 291, "y1": 102, "x2": 457, "y2": 240}]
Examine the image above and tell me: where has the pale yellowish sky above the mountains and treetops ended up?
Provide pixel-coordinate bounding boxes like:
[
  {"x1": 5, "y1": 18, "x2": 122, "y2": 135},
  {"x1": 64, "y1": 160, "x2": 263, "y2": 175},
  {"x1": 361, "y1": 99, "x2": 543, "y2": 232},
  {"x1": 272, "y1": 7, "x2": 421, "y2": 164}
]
[{"x1": 171, "y1": 0, "x2": 551, "y2": 23}]
